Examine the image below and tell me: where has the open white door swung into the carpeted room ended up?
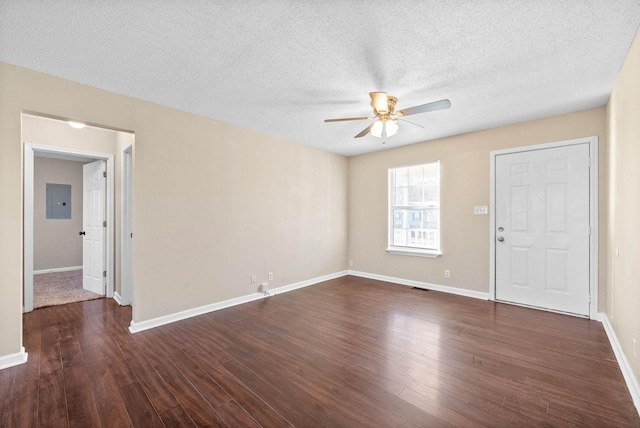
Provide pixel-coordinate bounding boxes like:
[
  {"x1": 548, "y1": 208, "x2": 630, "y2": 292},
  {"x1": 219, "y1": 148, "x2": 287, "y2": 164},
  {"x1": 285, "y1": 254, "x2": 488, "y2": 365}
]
[{"x1": 82, "y1": 160, "x2": 106, "y2": 295}]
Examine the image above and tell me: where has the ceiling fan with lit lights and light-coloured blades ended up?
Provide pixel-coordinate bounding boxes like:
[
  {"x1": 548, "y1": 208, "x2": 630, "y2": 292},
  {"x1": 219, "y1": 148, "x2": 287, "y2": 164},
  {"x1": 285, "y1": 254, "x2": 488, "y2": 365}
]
[{"x1": 325, "y1": 92, "x2": 451, "y2": 138}]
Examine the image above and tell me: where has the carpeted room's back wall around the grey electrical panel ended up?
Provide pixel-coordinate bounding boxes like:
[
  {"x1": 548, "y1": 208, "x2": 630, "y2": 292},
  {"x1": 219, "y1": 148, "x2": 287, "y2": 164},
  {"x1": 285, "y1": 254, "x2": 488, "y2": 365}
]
[{"x1": 33, "y1": 157, "x2": 82, "y2": 271}]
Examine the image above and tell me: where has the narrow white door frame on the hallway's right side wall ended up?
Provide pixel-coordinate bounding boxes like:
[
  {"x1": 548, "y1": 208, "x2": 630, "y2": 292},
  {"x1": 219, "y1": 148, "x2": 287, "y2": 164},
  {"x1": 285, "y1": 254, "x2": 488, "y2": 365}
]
[{"x1": 119, "y1": 144, "x2": 133, "y2": 305}]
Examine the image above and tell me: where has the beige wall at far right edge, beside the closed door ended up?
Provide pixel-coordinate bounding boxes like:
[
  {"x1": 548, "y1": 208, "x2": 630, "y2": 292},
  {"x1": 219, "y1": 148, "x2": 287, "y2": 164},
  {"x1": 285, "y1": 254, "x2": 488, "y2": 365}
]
[{"x1": 606, "y1": 25, "x2": 640, "y2": 383}]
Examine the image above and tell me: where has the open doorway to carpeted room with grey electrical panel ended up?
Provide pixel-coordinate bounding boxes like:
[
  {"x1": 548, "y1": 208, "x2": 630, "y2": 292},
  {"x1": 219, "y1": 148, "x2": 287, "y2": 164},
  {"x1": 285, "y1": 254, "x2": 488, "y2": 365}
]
[{"x1": 33, "y1": 151, "x2": 106, "y2": 309}]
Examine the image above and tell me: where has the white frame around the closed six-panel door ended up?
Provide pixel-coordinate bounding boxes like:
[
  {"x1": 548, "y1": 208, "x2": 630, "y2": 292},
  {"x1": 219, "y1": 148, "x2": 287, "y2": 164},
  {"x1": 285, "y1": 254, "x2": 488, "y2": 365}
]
[{"x1": 489, "y1": 136, "x2": 599, "y2": 319}]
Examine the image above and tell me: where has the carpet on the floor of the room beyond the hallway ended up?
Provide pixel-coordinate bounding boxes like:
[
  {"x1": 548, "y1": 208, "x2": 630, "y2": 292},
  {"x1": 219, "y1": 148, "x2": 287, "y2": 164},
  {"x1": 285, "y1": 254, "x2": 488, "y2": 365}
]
[{"x1": 33, "y1": 269, "x2": 104, "y2": 309}]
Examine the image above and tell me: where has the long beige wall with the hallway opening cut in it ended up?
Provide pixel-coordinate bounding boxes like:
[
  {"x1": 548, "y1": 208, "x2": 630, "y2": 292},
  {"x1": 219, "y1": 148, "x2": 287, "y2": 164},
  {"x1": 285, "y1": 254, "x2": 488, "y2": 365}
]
[{"x1": 0, "y1": 64, "x2": 348, "y2": 356}]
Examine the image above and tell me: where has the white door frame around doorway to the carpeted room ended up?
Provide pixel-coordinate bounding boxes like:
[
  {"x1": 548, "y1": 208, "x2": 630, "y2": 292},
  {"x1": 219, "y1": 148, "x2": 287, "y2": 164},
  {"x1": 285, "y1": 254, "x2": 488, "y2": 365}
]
[{"x1": 23, "y1": 143, "x2": 114, "y2": 312}]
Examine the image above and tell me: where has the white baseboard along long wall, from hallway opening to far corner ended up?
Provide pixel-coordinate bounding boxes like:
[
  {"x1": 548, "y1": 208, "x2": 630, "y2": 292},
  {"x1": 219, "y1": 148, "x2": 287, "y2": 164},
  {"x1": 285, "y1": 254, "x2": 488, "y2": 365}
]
[{"x1": 129, "y1": 271, "x2": 347, "y2": 333}]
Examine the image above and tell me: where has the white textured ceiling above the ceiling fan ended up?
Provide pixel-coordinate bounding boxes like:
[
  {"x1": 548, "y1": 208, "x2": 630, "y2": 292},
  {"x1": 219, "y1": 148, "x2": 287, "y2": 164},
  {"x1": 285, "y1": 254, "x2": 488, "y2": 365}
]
[{"x1": 0, "y1": 0, "x2": 640, "y2": 155}]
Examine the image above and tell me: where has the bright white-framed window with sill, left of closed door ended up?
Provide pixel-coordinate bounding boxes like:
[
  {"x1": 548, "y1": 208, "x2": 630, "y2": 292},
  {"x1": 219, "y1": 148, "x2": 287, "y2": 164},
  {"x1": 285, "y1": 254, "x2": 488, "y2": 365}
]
[{"x1": 387, "y1": 162, "x2": 440, "y2": 257}]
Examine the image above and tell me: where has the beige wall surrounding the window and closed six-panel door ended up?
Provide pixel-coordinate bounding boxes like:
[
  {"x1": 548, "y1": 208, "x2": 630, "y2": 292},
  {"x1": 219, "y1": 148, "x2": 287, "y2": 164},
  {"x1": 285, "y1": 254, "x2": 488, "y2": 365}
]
[{"x1": 349, "y1": 107, "x2": 606, "y2": 299}]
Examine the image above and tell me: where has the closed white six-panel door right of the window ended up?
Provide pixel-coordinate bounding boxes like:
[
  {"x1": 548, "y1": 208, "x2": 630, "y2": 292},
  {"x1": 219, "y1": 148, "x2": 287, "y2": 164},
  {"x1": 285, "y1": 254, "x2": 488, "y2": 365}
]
[{"x1": 495, "y1": 143, "x2": 590, "y2": 316}]
